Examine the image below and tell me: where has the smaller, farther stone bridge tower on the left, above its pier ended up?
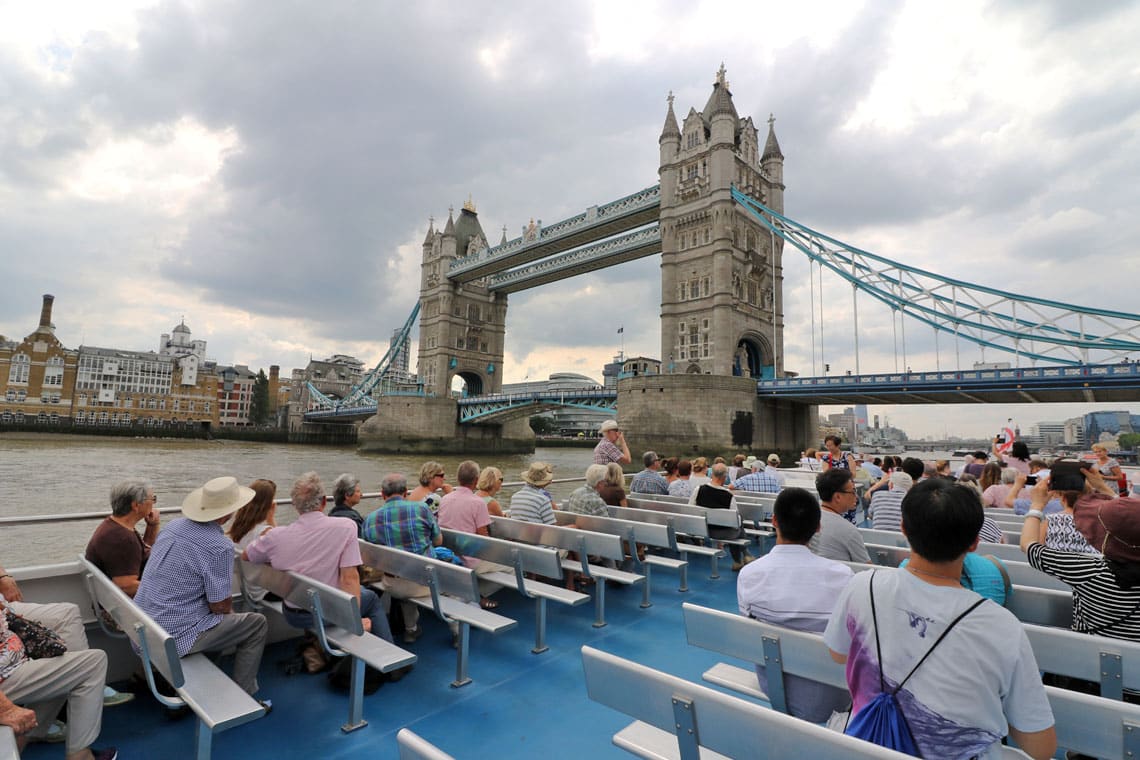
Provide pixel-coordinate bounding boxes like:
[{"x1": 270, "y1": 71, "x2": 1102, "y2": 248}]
[{"x1": 418, "y1": 199, "x2": 506, "y2": 397}]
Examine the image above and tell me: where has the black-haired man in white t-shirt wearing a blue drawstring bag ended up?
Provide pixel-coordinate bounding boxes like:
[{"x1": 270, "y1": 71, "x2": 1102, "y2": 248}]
[{"x1": 823, "y1": 479, "x2": 1057, "y2": 760}]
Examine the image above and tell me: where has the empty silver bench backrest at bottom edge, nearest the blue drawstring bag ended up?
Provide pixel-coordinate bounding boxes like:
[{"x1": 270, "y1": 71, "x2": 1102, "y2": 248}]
[{"x1": 581, "y1": 646, "x2": 907, "y2": 760}]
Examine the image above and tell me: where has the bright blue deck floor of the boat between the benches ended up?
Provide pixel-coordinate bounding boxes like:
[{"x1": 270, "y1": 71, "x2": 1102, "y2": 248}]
[{"x1": 24, "y1": 559, "x2": 736, "y2": 760}]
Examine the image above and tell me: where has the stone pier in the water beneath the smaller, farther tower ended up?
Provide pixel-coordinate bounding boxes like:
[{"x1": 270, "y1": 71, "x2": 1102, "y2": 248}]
[{"x1": 358, "y1": 395, "x2": 535, "y2": 457}]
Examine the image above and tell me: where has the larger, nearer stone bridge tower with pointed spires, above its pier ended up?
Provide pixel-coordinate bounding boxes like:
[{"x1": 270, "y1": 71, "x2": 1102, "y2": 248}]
[{"x1": 659, "y1": 65, "x2": 784, "y2": 378}]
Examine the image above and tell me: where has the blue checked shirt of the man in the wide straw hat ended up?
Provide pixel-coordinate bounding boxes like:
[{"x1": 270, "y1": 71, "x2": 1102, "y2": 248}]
[{"x1": 135, "y1": 517, "x2": 234, "y2": 657}]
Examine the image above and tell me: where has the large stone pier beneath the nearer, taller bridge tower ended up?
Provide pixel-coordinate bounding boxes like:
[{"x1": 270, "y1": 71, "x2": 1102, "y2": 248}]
[{"x1": 618, "y1": 374, "x2": 819, "y2": 461}]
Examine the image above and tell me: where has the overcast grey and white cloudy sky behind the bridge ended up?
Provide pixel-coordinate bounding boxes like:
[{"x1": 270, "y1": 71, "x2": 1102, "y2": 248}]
[{"x1": 0, "y1": 0, "x2": 1140, "y2": 435}]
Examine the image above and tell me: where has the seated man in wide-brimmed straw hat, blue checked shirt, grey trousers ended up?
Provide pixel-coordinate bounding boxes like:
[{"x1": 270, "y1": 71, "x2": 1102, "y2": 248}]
[{"x1": 135, "y1": 477, "x2": 268, "y2": 694}]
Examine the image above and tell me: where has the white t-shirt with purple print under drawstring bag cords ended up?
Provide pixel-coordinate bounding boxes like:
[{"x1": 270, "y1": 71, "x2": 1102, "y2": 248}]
[{"x1": 823, "y1": 569, "x2": 1053, "y2": 760}]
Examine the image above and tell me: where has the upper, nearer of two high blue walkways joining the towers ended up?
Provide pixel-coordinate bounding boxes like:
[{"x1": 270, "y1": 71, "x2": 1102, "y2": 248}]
[{"x1": 447, "y1": 185, "x2": 661, "y2": 283}]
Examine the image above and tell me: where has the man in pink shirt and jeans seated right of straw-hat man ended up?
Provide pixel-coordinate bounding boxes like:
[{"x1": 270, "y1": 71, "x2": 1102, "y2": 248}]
[{"x1": 242, "y1": 472, "x2": 392, "y2": 641}]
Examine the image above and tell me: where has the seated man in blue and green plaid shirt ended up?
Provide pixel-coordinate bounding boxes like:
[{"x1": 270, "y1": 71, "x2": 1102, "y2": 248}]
[{"x1": 364, "y1": 471, "x2": 440, "y2": 644}]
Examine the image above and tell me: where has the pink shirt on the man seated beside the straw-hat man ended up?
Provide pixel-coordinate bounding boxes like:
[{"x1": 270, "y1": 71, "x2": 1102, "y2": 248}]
[{"x1": 245, "y1": 512, "x2": 360, "y2": 588}]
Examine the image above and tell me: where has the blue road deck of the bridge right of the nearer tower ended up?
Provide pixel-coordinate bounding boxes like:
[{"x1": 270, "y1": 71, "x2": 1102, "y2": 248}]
[{"x1": 756, "y1": 363, "x2": 1140, "y2": 406}]
